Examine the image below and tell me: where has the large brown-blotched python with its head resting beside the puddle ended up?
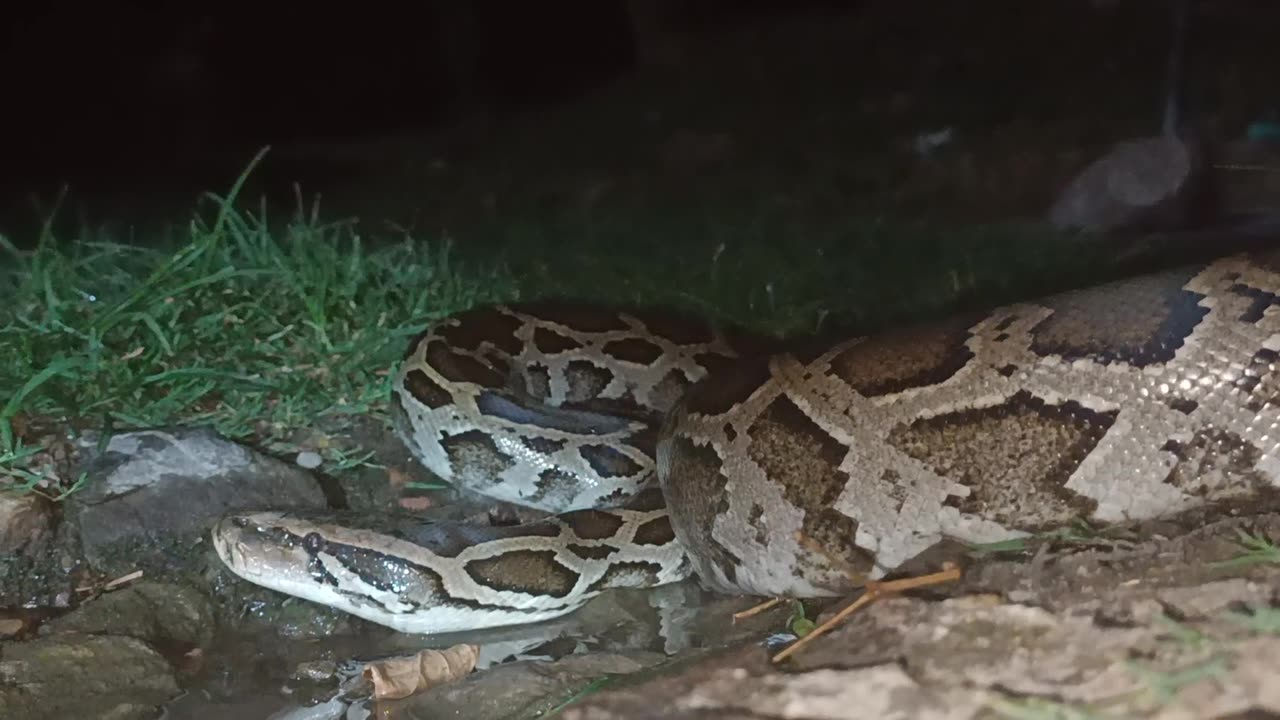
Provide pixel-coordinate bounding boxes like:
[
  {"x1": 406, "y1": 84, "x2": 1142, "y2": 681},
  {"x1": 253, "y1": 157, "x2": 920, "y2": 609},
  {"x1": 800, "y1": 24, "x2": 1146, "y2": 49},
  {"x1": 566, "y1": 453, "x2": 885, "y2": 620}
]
[{"x1": 212, "y1": 251, "x2": 1280, "y2": 633}]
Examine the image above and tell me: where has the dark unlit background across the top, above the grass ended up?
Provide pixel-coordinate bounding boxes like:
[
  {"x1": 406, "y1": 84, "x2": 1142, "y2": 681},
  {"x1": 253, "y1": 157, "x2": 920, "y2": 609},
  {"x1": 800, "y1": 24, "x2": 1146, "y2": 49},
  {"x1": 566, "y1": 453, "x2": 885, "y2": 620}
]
[{"x1": 0, "y1": 0, "x2": 1280, "y2": 234}]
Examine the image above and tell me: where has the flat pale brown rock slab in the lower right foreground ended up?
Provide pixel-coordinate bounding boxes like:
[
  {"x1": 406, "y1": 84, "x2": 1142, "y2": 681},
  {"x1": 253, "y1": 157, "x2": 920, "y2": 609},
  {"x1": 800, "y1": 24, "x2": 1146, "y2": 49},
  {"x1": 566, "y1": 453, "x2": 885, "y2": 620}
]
[{"x1": 563, "y1": 598, "x2": 1280, "y2": 720}]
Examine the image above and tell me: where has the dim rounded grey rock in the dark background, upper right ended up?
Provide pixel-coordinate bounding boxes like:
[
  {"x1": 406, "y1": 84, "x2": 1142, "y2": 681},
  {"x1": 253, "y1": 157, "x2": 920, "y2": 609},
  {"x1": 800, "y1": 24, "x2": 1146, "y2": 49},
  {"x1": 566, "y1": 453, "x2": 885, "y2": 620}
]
[{"x1": 1050, "y1": 136, "x2": 1204, "y2": 233}]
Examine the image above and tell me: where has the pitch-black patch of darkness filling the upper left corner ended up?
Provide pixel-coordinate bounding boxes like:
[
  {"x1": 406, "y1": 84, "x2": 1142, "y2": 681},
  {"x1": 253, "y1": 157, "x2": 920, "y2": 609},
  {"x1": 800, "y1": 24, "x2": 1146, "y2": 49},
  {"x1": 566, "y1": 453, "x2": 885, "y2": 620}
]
[{"x1": 0, "y1": 0, "x2": 858, "y2": 186}]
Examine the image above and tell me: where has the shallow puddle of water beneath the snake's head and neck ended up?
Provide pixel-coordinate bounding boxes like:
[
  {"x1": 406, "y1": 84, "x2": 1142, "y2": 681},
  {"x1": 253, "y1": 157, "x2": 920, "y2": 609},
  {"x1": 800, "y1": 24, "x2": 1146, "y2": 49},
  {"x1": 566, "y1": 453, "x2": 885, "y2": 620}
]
[{"x1": 166, "y1": 580, "x2": 764, "y2": 720}]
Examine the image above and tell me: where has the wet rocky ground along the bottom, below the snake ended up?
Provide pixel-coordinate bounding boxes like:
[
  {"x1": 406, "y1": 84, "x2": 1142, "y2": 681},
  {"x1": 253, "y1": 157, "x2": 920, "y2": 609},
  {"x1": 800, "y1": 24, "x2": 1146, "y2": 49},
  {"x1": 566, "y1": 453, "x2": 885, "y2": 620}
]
[{"x1": 0, "y1": 420, "x2": 1280, "y2": 720}]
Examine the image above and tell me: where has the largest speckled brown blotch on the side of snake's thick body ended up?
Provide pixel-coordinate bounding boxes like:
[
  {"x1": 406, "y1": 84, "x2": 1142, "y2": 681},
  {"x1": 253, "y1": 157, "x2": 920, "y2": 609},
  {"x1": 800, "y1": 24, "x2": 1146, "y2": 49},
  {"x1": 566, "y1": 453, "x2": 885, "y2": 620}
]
[{"x1": 888, "y1": 392, "x2": 1116, "y2": 530}]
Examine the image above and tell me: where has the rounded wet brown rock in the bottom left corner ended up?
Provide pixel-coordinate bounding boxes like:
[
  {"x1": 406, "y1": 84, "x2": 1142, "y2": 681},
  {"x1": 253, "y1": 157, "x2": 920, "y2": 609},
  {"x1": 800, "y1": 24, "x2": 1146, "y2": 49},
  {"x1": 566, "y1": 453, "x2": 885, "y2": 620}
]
[{"x1": 0, "y1": 633, "x2": 179, "y2": 720}]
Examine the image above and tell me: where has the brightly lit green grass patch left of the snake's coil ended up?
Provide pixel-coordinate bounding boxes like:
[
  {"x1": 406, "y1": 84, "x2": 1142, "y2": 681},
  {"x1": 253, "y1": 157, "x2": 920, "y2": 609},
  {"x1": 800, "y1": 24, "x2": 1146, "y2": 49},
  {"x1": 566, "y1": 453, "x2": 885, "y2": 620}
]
[{"x1": 0, "y1": 153, "x2": 509, "y2": 492}]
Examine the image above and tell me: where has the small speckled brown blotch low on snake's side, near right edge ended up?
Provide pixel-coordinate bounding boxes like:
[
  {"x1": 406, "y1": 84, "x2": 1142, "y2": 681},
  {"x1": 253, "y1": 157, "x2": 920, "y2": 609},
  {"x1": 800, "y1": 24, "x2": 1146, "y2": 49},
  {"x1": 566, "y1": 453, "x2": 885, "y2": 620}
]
[{"x1": 1164, "y1": 428, "x2": 1267, "y2": 496}]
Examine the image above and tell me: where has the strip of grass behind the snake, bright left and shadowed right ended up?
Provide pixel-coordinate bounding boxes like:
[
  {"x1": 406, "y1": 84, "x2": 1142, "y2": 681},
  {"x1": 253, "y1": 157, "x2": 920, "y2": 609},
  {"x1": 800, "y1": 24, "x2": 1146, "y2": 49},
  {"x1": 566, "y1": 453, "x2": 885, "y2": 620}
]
[{"x1": 0, "y1": 134, "x2": 1131, "y2": 498}]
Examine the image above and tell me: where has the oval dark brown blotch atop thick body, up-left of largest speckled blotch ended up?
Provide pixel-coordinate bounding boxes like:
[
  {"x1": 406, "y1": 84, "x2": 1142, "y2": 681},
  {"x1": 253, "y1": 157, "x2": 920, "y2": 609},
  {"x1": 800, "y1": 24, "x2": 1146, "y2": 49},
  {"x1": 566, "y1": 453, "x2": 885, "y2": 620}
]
[{"x1": 831, "y1": 318, "x2": 973, "y2": 397}]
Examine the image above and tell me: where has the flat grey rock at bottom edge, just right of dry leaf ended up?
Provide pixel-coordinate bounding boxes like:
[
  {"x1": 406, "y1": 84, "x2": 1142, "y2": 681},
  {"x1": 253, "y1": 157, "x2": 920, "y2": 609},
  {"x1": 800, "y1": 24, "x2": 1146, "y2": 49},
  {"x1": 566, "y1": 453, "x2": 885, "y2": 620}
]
[{"x1": 389, "y1": 652, "x2": 666, "y2": 720}]
